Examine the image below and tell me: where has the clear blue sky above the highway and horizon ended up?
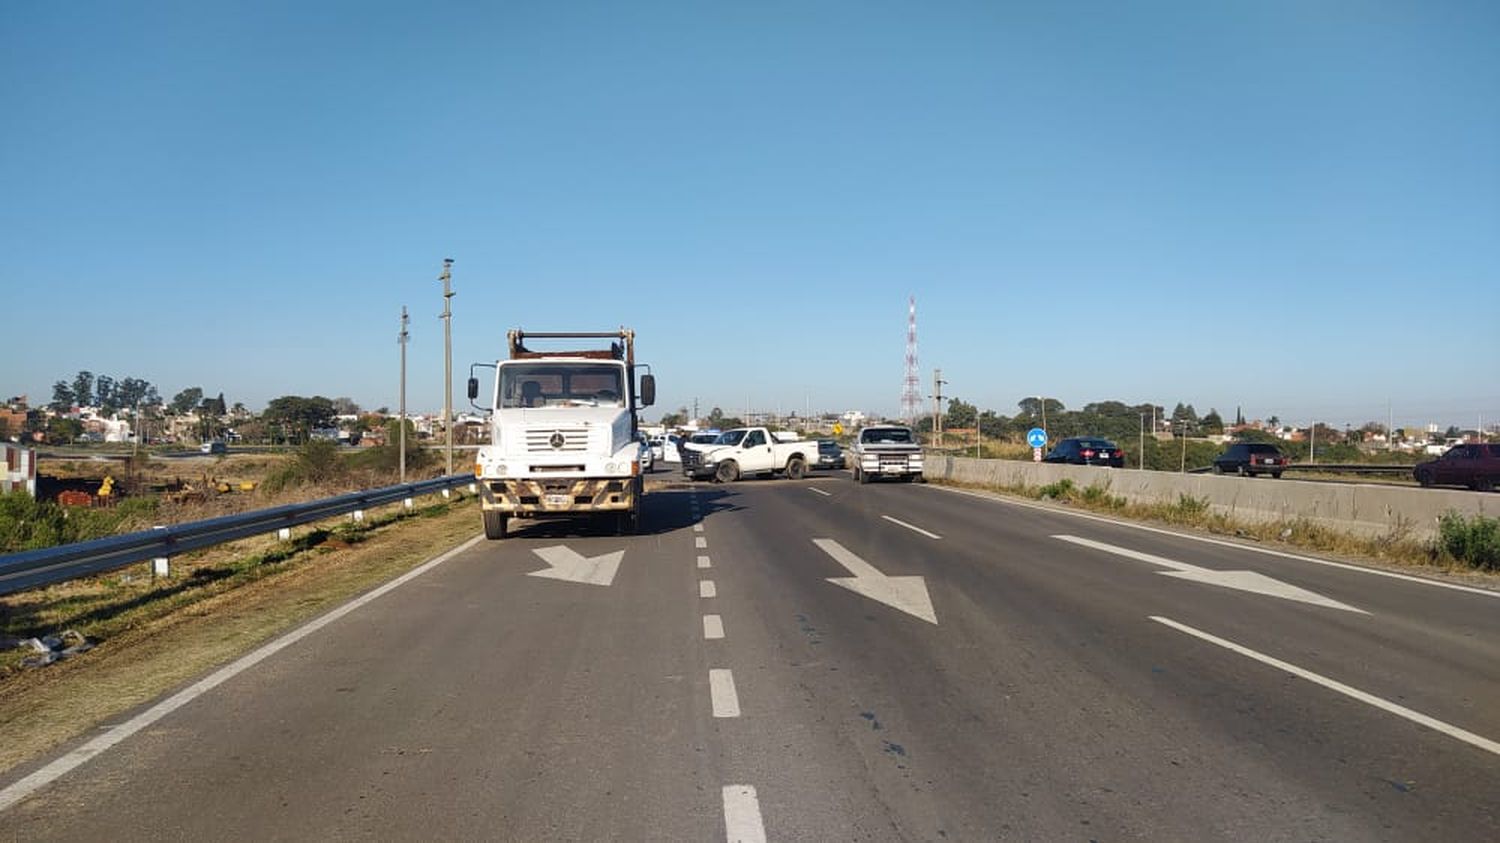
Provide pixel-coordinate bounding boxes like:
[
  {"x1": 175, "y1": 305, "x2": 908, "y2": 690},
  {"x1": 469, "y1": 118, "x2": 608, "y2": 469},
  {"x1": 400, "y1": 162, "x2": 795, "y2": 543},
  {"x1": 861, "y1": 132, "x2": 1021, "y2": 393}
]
[{"x1": 0, "y1": 0, "x2": 1500, "y2": 426}]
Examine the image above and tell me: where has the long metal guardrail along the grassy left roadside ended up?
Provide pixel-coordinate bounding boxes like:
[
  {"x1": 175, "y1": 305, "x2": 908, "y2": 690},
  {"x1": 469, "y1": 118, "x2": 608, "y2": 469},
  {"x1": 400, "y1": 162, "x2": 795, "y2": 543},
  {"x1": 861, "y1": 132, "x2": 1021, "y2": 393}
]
[{"x1": 0, "y1": 474, "x2": 474, "y2": 594}]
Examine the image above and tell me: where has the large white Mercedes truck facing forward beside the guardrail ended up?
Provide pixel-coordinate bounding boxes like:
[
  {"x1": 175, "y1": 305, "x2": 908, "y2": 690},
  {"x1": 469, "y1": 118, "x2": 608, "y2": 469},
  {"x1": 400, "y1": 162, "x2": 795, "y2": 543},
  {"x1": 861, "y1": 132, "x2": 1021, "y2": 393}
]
[{"x1": 468, "y1": 329, "x2": 656, "y2": 539}]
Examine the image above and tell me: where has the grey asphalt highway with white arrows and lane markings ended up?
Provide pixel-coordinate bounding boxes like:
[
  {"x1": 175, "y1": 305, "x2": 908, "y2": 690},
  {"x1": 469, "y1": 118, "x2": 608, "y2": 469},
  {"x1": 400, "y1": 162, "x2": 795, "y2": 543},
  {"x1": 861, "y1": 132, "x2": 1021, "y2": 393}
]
[{"x1": 0, "y1": 474, "x2": 1500, "y2": 840}]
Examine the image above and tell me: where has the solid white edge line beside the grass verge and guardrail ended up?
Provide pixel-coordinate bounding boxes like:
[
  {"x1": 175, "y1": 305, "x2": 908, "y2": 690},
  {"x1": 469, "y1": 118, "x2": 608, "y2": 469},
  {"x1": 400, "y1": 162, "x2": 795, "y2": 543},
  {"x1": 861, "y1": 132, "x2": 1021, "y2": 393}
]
[{"x1": 0, "y1": 536, "x2": 485, "y2": 812}]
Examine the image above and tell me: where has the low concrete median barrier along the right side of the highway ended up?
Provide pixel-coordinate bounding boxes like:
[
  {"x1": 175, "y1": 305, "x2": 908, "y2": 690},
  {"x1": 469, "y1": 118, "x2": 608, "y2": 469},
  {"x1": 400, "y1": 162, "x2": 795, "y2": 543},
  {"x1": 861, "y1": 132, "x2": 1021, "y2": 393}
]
[{"x1": 927, "y1": 456, "x2": 1500, "y2": 539}]
